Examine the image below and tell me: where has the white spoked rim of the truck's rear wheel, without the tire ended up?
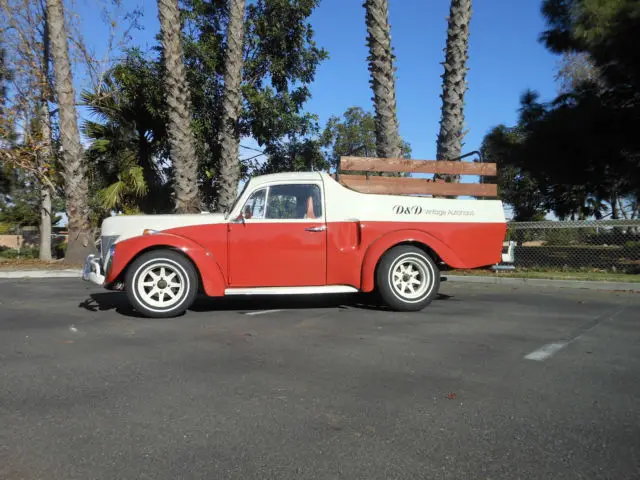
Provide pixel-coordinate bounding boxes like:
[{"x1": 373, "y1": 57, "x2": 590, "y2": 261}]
[{"x1": 389, "y1": 253, "x2": 433, "y2": 302}]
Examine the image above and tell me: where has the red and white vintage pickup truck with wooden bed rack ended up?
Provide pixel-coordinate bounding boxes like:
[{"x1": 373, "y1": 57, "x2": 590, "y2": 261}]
[{"x1": 83, "y1": 157, "x2": 506, "y2": 317}]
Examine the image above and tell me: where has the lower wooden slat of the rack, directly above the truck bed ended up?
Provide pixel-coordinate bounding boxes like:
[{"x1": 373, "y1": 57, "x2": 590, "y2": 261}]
[{"x1": 339, "y1": 174, "x2": 498, "y2": 197}]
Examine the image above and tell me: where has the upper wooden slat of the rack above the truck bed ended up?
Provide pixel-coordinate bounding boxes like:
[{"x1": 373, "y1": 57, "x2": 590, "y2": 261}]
[{"x1": 340, "y1": 157, "x2": 497, "y2": 176}]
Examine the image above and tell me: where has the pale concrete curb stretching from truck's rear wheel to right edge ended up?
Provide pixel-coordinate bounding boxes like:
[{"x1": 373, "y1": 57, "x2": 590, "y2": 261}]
[{"x1": 443, "y1": 275, "x2": 640, "y2": 292}]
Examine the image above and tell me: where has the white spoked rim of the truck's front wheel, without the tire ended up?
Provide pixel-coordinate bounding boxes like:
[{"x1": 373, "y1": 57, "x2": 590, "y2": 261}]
[{"x1": 136, "y1": 261, "x2": 189, "y2": 310}]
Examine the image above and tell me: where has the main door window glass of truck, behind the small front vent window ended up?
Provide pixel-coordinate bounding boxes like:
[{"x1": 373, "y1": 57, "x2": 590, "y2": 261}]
[{"x1": 266, "y1": 184, "x2": 322, "y2": 220}]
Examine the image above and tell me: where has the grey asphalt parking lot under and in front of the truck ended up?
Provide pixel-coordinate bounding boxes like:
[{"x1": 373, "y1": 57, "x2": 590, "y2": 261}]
[{"x1": 0, "y1": 279, "x2": 640, "y2": 480}]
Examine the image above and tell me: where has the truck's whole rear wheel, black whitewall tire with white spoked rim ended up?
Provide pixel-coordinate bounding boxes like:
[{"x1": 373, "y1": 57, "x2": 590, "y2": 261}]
[{"x1": 376, "y1": 245, "x2": 440, "y2": 312}]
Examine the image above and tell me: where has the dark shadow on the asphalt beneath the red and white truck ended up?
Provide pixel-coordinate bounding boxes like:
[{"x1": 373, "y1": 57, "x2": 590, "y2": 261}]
[{"x1": 78, "y1": 292, "x2": 451, "y2": 318}]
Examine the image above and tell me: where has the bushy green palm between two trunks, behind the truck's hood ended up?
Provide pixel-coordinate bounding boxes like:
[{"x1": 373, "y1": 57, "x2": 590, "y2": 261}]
[{"x1": 81, "y1": 50, "x2": 173, "y2": 215}]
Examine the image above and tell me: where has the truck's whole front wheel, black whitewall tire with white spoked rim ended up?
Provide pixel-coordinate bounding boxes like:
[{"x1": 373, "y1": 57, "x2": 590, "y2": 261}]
[{"x1": 125, "y1": 249, "x2": 199, "y2": 318}]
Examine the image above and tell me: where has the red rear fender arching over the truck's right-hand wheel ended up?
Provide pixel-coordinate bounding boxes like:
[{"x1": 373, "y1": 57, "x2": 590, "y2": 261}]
[{"x1": 360, "y1": 230, "x2": 463, "y2": 292}]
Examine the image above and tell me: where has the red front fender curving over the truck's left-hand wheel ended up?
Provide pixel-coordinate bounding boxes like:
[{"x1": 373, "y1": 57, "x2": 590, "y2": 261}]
[{"x1": 105, "y1": 232, "x2": 226, "y2": 297}]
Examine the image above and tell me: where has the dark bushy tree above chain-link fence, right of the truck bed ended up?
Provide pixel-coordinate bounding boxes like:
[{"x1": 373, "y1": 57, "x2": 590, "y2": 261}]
[{"x1": 483, "y1": 88, "x2": 632, "y2": 220}]
